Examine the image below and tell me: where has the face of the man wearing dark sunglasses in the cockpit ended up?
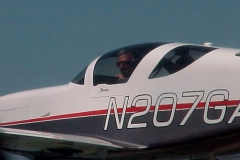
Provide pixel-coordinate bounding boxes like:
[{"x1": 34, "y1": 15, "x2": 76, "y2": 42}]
[{"x1": 117, "y1": 54, "x2": 132, "y2": 74}]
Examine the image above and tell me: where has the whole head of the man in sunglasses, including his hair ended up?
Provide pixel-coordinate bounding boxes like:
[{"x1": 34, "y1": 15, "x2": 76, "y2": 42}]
[{"x1": 117, "y1": 50, "x2": 134, "y2": 77}]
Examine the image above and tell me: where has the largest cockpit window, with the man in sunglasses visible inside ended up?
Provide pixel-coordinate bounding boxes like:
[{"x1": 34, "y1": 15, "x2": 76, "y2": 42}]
[{"x1": 93, "y1": 43, "x2": 166, "y2": 86}]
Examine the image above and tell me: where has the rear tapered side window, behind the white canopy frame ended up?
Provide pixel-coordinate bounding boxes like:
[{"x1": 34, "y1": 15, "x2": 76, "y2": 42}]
[{"x1": 149, "y1": 46, "x2": 216, "y2": 79}]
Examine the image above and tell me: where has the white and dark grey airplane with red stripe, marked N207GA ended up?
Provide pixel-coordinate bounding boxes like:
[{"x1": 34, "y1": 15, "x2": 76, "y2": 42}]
[{"x1": 0, "y1": 42, "x2": 240, "y2": 160}]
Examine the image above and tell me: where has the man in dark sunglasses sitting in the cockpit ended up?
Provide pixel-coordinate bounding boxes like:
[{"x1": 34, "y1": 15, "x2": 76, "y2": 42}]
[{"x1": 116, "y1": 50, "x2": 135, "y2": 83}]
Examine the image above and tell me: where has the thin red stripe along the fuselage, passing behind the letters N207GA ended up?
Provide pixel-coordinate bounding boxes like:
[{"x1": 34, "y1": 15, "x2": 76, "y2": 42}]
[{"x1": 0, "y1": 100, "x2": 240, "y2": 126}]
